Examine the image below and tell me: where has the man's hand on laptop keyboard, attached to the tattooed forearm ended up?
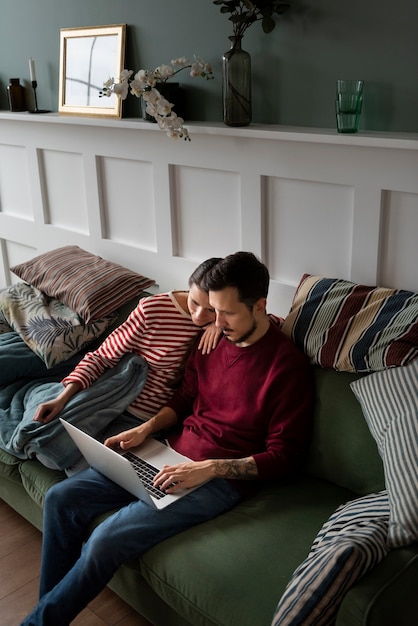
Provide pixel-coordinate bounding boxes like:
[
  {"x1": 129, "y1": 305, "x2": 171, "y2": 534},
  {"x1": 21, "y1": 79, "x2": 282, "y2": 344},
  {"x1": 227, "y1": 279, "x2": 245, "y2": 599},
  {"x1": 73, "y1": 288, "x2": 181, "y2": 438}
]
[{"x1": 154, "y1": 460, "x2": 214, "y2": 493}]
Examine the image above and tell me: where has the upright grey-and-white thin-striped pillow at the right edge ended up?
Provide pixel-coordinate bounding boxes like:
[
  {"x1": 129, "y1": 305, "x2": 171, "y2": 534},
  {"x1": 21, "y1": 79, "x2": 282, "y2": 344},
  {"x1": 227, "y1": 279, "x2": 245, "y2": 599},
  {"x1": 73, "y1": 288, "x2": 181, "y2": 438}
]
[{"x1": 351, "y1": 360, "x2": 418, "y2": 548}]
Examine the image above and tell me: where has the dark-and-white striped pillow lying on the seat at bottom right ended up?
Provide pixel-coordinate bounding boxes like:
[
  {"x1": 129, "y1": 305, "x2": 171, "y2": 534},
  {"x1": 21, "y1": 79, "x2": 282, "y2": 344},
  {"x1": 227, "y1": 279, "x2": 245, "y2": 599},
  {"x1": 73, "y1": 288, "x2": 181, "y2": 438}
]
[{"x1": 271, "y1": 491, "x2": 389, "y2": 626}]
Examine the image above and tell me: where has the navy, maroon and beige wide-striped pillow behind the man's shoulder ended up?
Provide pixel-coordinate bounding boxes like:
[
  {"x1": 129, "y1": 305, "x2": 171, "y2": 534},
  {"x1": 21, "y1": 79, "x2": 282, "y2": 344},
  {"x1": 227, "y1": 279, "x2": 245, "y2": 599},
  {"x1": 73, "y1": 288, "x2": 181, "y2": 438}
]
[{"x1": 282, "y1": 274, "x2": 418, "y2": 372}]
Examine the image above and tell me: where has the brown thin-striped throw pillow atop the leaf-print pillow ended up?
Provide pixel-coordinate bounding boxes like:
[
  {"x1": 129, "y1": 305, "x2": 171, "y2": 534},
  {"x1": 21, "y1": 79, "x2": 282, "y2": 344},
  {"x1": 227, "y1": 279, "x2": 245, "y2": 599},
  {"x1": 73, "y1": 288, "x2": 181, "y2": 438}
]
[{"x1": 10, "y1": 246, "x2": 155, "y2": 324}]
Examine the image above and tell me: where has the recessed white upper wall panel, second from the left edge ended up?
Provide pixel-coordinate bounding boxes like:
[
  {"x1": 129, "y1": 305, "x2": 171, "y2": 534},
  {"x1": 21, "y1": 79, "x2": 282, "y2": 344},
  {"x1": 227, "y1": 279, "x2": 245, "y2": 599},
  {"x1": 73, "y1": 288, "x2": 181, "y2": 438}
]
[{"x1": 39, "y1": 150, "x2": 89, "y2": 235}]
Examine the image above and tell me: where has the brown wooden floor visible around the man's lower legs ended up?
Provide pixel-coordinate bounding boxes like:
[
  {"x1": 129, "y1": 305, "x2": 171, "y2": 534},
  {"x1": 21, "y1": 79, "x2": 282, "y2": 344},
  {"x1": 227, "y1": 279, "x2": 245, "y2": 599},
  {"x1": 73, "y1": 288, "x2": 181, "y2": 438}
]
[{"x1": 0, "y1": 500, "x2": 152, "y2": 626}]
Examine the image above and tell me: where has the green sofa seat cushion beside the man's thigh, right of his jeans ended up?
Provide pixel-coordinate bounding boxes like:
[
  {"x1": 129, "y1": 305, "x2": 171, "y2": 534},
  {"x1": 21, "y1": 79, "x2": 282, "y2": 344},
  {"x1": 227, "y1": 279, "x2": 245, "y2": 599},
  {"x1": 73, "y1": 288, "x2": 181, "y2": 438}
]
[{"x1": 141, "y1": 477, "x2": 352, "y2": 626}]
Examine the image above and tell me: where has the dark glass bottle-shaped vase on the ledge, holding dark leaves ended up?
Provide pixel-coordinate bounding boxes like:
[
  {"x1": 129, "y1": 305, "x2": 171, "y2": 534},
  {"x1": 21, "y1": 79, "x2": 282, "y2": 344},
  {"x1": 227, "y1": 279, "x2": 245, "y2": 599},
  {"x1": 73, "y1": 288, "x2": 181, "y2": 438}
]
[{"x1": 222, "y1": 36, "x2": 251, "y2": 126}]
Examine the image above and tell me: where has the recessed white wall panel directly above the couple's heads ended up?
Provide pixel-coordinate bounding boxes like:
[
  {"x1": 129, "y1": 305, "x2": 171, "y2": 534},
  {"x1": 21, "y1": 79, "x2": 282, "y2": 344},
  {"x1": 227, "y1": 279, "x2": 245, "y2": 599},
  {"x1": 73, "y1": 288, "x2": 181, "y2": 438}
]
[{"x1": 172, "y1": 166, "x2": 241, "y2": 263}]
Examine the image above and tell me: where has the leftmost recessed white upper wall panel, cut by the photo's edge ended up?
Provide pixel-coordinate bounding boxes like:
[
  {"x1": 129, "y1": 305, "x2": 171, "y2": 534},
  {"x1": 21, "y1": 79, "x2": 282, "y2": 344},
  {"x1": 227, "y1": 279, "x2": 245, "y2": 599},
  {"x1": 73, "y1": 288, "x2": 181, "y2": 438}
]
[{"x1": 0, "y1": 144, "x2": 33, "y2": 220}]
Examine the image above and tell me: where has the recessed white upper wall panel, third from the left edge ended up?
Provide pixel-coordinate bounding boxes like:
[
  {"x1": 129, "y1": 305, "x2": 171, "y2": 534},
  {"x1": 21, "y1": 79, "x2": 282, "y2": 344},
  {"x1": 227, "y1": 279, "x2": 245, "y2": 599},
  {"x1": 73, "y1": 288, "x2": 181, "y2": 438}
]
[{"x1": 98, "y1": 157, "x2": 157, "y2": 251}]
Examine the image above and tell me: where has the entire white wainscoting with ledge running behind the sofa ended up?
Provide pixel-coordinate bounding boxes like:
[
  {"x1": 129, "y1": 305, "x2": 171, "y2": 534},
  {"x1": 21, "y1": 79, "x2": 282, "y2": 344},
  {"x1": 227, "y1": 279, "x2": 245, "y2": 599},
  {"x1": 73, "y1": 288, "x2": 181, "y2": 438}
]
[{"x1": 0, "y1": 111, "x2": 418, "y2": 315}]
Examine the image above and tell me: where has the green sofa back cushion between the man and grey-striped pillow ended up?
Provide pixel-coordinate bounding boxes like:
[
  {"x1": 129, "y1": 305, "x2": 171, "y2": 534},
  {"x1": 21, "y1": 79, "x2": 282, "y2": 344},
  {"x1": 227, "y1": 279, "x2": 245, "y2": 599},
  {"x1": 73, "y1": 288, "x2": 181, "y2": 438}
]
[{"x1": 307, "y1": 367, "x2": 385, "y2": 495}]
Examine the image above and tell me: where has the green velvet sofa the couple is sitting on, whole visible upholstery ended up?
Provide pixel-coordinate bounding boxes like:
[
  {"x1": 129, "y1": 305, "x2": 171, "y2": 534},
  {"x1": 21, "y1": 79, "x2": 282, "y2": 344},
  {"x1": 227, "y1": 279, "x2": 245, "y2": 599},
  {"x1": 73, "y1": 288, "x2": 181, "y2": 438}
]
[{"x1": 0, "y1": 368, "x2": 418, "y2": 626}]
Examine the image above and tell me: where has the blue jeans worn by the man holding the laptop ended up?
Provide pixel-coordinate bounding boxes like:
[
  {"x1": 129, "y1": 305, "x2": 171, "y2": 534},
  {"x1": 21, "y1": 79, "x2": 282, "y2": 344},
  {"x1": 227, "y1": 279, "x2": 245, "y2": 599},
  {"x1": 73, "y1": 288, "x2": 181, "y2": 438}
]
[{"x1": 22, "y1": 468, "x2": 242, "y2": 626}]
